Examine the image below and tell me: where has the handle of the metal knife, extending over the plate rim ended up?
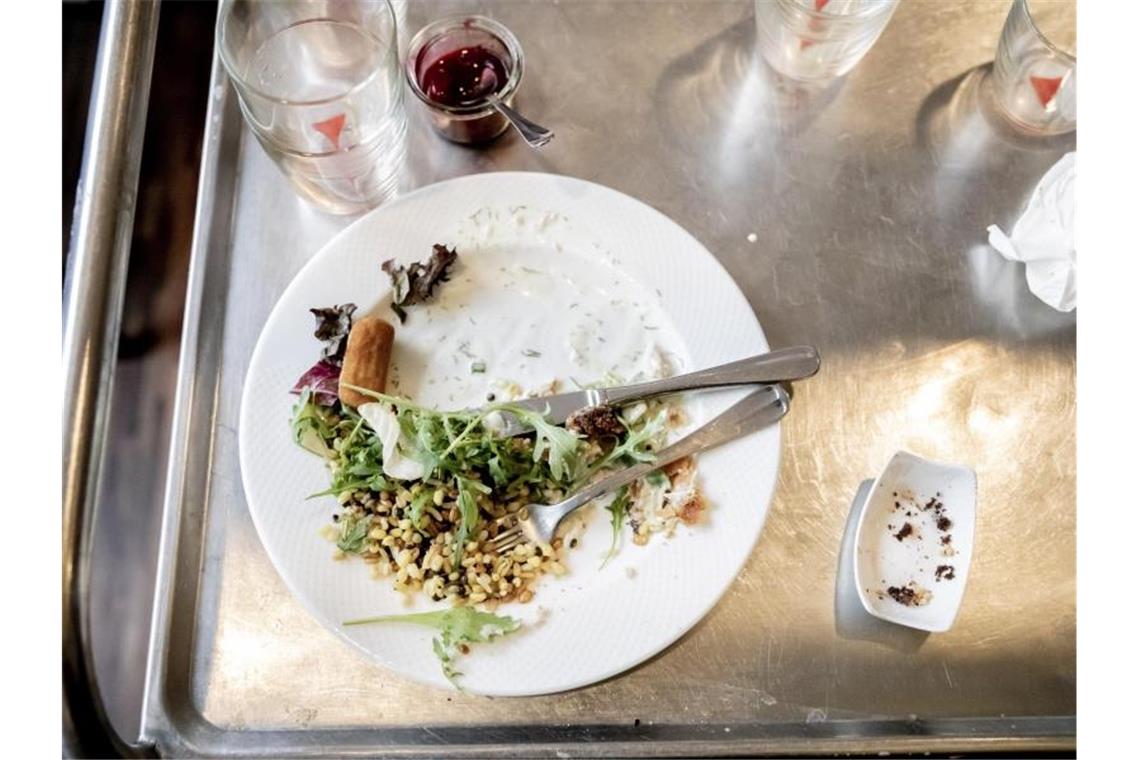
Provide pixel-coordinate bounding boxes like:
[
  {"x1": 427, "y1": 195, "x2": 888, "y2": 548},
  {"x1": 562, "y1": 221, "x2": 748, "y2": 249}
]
[{"x1": 604, "y1": 345, "x2": 820, "y2": 404}]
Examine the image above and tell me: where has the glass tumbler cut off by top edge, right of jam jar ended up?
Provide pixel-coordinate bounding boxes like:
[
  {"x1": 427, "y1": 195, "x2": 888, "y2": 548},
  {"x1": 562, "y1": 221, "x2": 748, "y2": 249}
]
[{"x1": 756, "y1": 0, "x2": 898, "y2": 81}]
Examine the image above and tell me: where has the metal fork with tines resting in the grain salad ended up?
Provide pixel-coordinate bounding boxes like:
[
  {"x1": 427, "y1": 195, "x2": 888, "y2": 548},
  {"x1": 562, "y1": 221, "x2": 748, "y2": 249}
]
[{"x1": 490, "y1": 385, "x2": 790, "y2": 554}]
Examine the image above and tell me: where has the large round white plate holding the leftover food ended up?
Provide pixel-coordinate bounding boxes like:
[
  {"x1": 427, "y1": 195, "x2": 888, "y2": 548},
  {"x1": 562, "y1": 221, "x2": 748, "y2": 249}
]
[{"x1": 239, "y1": 173, "x2": 780, "y2": 695}]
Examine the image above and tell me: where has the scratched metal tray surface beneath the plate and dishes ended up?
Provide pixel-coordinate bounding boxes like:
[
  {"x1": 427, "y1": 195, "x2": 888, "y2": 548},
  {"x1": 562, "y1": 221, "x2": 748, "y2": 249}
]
[{"x1": 137, "y1": 1, "x2": 1076, "y2": 755}]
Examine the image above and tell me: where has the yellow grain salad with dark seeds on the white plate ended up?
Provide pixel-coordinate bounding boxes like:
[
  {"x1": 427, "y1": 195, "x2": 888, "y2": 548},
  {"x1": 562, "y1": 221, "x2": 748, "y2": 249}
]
[{"x1": 307, "y1": 389, "x2": 703, "y2": 608}]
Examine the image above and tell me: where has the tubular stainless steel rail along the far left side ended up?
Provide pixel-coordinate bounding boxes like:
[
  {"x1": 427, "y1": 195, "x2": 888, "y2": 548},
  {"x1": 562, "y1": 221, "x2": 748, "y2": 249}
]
[{"x1": 63, "y1": 0, "x2": 158, "y2": 757}]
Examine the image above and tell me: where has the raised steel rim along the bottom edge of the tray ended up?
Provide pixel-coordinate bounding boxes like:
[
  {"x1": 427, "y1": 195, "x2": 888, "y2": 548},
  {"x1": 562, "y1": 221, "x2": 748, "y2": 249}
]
[{"x1": 147, "y1": 716, "x2": 1076, "y2": 758}]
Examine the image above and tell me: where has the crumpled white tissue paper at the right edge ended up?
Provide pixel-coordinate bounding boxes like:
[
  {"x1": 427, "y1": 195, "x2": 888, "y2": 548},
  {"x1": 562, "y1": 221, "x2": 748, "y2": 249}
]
[{"x1": 987, "y1": 153, "x2": 1076, "y2": 311}]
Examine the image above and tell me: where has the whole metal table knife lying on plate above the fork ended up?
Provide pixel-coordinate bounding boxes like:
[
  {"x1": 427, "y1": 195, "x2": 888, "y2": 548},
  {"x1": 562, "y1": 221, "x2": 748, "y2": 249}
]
[{"x1": 495, "y1": 345, "x2": 820, "y2": 436}]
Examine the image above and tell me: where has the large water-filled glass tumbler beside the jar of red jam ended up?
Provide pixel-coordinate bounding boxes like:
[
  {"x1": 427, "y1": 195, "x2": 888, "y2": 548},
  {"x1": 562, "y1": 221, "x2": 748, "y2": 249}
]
[{"x1": 217, "y1": 0, "x2": 407, "y2": 214}]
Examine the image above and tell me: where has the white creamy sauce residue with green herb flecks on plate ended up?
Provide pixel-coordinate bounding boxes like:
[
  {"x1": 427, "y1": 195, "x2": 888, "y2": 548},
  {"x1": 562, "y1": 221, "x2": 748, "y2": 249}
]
[{"x1": 380, "y1": 209, "x2": 689, "y2": 409}]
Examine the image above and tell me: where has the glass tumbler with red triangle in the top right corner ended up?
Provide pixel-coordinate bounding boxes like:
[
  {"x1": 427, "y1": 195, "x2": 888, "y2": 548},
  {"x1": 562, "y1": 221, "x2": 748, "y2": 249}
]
[{"x1": 991, "y1": 0, "x2": 1076, "y2": 134}]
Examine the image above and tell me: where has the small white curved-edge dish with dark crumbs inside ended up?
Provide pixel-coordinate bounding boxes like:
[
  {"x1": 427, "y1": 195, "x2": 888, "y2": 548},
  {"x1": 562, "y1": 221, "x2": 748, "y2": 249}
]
[{"x1": 855, "y1": 451, "x2": 978, "y2": 632}]
